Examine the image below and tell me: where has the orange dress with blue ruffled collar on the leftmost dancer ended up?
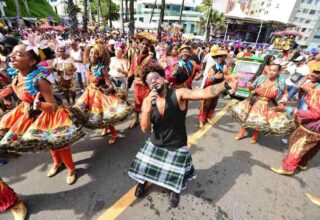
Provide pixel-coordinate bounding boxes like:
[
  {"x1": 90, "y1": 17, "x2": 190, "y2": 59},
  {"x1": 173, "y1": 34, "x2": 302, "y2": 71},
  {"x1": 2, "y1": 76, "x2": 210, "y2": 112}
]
[{"x1": 0, "y1": 67, "x2": 84, "y2": 153}]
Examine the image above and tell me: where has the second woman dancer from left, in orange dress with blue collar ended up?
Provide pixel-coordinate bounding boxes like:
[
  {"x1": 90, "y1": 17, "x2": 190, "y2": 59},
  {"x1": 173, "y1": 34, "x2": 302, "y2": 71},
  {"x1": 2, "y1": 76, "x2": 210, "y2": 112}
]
[{"x1": 72, "y1": 44, "x2": 132, "y2": 144}]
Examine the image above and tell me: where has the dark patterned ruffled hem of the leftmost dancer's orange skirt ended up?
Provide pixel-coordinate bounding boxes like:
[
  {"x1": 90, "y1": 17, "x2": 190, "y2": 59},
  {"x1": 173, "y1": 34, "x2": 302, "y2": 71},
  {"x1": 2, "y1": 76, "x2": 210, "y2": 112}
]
[{"x1": 0, "y1": 127, "x2": 85, "y2": 154}]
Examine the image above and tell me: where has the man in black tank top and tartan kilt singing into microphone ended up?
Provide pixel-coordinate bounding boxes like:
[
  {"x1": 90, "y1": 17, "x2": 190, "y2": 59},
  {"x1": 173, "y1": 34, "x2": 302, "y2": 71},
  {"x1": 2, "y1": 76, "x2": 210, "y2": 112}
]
[{"x1": 128, "y1": 65, "x2": 227, "y2": 207}]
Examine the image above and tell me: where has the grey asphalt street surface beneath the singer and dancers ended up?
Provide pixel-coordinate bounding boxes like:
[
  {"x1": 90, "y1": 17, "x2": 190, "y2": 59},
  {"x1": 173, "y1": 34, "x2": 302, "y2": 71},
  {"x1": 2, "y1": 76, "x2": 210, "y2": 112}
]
[{"x1": 0, "y1": 88, "x2": 320, "y2": 220}]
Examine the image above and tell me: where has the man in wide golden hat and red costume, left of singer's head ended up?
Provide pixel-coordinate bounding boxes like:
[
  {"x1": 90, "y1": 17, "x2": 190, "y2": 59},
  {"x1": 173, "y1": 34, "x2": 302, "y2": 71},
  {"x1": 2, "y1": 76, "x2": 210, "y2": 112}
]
[{"x1": 129, "y1": 32, "x2": 157, "y2": 128}]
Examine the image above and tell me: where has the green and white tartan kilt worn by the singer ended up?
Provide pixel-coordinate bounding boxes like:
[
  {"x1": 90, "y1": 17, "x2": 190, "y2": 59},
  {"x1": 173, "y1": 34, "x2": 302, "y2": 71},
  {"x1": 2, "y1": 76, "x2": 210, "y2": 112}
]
[{"x1": 128, "y1": 141, "x2": 196, "y2": 193}]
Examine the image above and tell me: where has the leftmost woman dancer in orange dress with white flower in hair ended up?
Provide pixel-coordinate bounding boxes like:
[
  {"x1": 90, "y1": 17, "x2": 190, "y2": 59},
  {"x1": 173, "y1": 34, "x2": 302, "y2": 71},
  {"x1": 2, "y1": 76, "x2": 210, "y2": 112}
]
[{"x1": 0, "y1": 37, "x2": 84, "y2": 184}]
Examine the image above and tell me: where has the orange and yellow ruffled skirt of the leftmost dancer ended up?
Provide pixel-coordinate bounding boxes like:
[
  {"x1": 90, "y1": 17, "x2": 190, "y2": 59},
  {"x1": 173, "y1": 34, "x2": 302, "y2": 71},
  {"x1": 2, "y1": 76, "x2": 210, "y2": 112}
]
[{"x1": 0, "y1": 102, "x2": 84, "y2": 153}]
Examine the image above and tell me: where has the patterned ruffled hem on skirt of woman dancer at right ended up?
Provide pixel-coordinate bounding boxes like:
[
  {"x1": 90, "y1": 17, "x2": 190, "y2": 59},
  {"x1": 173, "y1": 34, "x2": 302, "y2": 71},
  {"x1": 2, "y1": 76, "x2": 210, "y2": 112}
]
[{"x1": 229, "y1": 106, "x2": 296, "y2": 136}]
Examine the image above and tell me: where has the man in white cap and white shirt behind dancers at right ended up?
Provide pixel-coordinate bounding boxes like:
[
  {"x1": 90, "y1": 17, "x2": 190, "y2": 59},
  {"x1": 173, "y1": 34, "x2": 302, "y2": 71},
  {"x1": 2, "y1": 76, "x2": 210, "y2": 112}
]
[{"x1": 286, "y1": 55, "x2": 310, "y2": 100}]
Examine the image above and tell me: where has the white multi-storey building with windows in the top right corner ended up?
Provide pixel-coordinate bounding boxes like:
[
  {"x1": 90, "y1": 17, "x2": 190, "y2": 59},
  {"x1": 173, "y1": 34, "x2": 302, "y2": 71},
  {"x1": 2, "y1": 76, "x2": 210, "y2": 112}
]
[{"x1": 249, "y1": 0, "x2": 320, "y2": 46}]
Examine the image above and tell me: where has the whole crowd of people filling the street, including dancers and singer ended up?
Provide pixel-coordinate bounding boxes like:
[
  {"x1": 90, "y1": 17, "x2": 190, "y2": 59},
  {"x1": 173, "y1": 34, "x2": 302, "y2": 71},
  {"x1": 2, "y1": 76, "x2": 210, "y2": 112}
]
[{"x1": 0, "y1": 27, "x2": 320, "y2": 219}]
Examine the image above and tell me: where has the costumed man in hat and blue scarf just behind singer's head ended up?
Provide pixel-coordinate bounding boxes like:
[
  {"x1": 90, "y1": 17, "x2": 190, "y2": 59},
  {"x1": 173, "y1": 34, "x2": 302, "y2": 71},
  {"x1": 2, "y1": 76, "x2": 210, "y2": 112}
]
[{"x1": 170, "y1": 44, "x2": 201, "y2": 89}]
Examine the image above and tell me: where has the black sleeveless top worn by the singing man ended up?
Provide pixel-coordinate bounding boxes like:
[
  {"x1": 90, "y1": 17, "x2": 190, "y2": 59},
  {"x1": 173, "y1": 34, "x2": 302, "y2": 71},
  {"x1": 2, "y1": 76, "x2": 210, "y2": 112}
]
[{"x1": 151, "y1": 88, "x2": 188, "y2": 150}]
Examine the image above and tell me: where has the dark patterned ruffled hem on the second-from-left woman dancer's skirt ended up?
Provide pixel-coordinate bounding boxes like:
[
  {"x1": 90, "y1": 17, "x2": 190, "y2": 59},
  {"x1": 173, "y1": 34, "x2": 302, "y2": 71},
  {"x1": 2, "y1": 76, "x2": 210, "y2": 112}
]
[{"x1": 69, "y1": 105, "x2": 134, "y2": 129}]
